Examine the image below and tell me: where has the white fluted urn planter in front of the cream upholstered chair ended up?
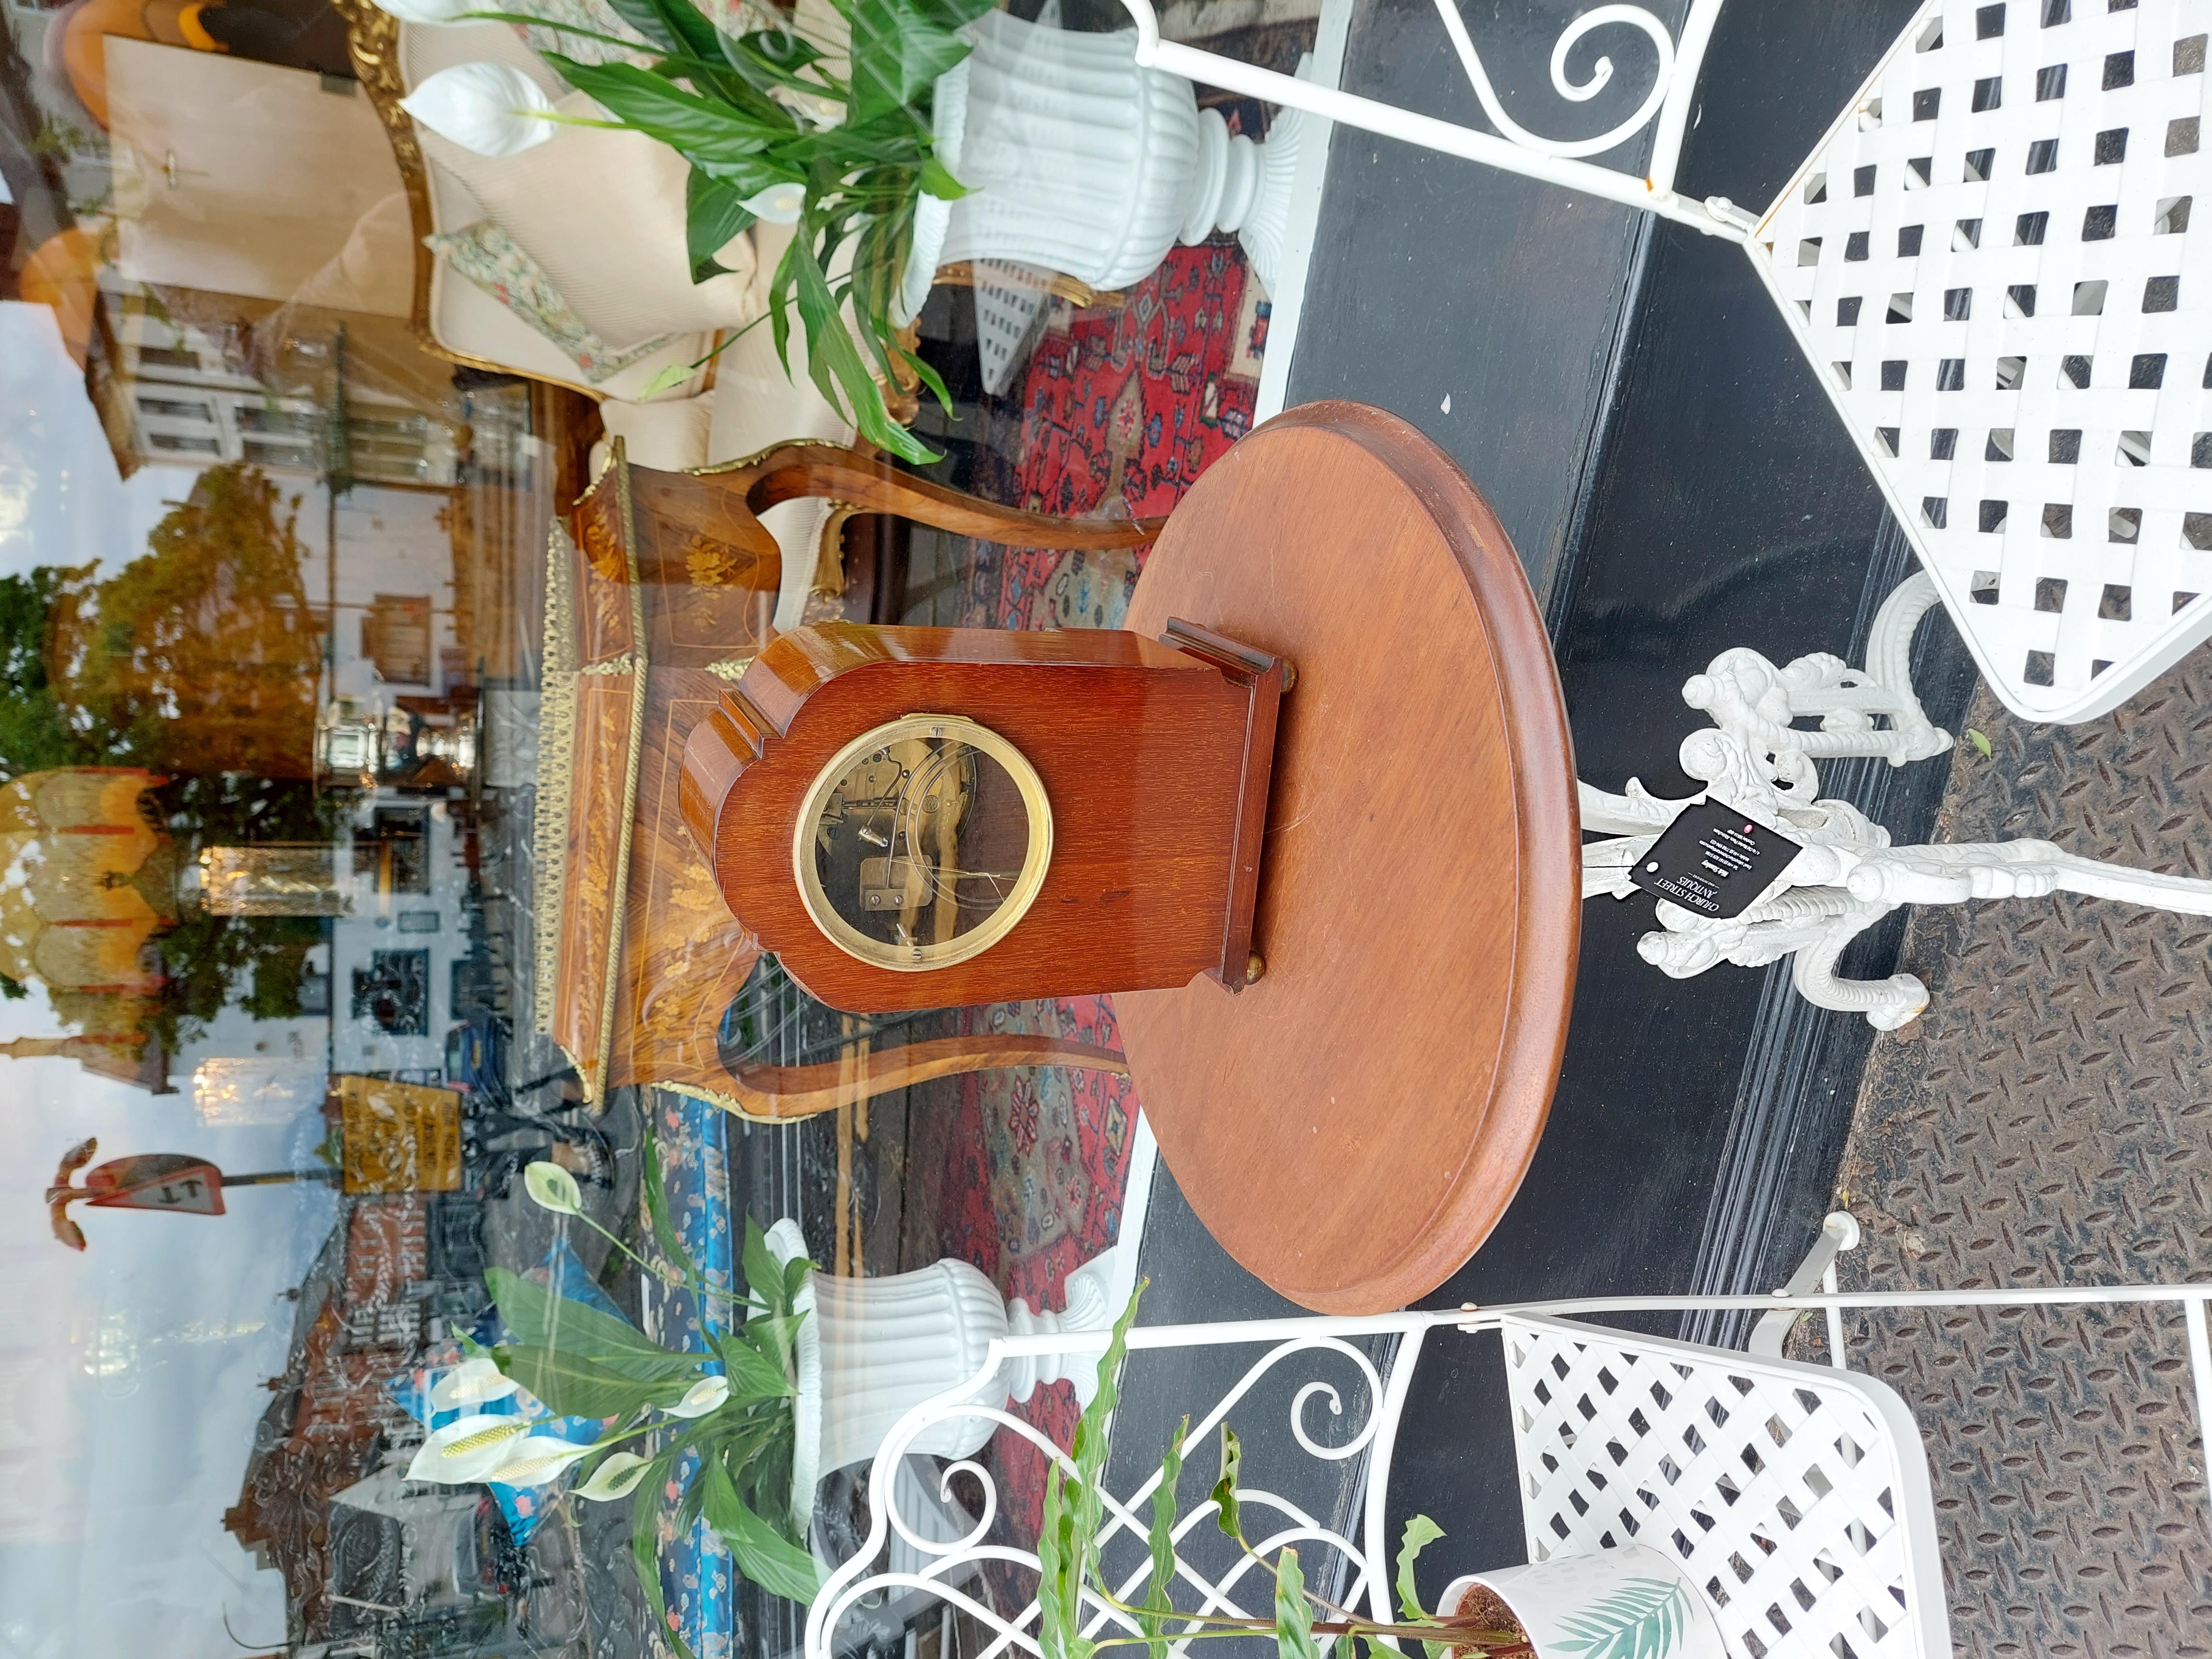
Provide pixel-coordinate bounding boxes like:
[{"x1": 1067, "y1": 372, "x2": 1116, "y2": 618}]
[{"x1": 900, "y1": 11, "x2": 1307, "y2": 321}]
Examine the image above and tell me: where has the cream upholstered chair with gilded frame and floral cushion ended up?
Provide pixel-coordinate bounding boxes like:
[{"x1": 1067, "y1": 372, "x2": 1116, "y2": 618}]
[{"x1": 341, "y1": 0, "x2": 854, "y2": 628}]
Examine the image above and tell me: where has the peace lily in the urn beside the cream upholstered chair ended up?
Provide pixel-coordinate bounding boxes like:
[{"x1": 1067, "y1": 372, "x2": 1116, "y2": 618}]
[{"x1": 380, "y1": 0, "x2": 991, "y2": 462}]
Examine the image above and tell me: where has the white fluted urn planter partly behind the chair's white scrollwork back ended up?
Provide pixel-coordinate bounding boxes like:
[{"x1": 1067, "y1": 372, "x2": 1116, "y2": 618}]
[{"x1": 768, "y1": 1221, "x2": 1115, "y2": 1513}]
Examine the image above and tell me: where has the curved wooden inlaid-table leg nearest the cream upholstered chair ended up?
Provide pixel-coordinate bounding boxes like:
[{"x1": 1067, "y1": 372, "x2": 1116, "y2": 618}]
[{"x1": 701, "y1": 444, "x2": 1168, "y2": 549}]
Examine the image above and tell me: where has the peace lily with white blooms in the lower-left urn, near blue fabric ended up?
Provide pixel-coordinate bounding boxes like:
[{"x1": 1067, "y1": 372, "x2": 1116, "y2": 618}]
[{"x1": 407, "y1": 1141, "x2": 818, "y2": 1650}]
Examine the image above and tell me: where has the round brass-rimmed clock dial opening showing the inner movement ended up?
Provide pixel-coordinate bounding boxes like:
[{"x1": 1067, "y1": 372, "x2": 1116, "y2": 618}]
[{"x1": 792, "y1": 715, "x2": 1053, "y2": 971}]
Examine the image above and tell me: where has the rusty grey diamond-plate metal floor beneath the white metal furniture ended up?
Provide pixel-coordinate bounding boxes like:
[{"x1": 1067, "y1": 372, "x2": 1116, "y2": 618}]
[{"x1": 1807, "y1": 653, "x2": 2212, "y2": 1659}]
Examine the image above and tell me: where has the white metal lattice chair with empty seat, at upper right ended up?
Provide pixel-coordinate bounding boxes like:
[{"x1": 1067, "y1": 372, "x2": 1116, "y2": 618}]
[{"x1": 1121, "y1": 0, "x2": 2212, "y2": 721}]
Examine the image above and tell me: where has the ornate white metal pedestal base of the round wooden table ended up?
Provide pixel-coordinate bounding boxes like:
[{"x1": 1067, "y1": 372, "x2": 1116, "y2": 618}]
[{"x1": 1582, "y1": 571, "x2": 2212, "y2": 1031}]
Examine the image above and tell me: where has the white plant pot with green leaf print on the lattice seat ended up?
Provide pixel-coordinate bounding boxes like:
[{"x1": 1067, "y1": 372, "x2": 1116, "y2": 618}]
[{"x1": 1438, "y1": 1544, "x2": 1727, "y2": 1659}]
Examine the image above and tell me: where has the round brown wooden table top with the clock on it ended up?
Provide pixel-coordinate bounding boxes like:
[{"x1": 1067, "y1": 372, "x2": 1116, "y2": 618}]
[{"x1": 1115, "y1": 403, "x2": 1582, "y2": 1314}]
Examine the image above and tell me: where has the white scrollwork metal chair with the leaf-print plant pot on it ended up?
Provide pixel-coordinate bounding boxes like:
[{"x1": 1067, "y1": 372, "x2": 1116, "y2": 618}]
[{"x1": 805, "y1": 1215, "x2": 2212, "y2": 1659}]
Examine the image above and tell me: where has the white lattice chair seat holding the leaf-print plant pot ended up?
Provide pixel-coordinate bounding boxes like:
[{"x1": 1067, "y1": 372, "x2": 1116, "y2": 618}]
[{"x1": 1500, "y1": 1316, "x2": 1951, "y2": 1659}]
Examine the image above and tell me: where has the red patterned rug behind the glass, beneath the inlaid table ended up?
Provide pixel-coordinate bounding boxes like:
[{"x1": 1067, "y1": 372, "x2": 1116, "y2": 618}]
[{"x1": 942, "y1": 241, "x2": 1270, "y2": 1539}]
